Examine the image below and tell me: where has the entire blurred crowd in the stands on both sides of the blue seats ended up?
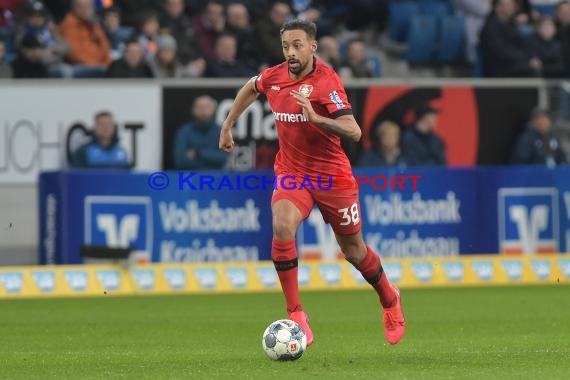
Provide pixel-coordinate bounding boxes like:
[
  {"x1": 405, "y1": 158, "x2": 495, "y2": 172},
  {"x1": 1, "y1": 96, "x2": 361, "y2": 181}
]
[{"x1": 0, "y1": 0, "x2": 570, "y2": 79}]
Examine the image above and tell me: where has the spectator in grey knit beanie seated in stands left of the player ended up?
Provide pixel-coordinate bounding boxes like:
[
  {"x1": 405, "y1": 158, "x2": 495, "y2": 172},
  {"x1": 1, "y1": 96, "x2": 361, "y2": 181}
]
[{"x1": 150, "y1": 34, "x2": 205, "y2": 78}]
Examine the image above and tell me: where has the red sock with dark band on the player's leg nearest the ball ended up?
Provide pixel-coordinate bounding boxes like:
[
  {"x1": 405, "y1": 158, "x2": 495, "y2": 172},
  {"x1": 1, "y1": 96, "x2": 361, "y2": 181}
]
[{"x1": 271, "y1": 239, "x2": 303, "y2": 313}]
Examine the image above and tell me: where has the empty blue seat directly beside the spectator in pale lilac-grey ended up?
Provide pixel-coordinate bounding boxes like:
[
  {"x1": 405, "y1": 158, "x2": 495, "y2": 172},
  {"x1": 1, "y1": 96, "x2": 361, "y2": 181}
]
[{"x1": 436, "y1": 16, "x2": 465, "y2": 63}]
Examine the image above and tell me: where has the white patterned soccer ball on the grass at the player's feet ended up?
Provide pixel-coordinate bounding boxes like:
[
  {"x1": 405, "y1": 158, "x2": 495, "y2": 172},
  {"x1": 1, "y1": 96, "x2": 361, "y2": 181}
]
[{"x1": 261, "y1": 319, "x2": 307, "y2": 361}]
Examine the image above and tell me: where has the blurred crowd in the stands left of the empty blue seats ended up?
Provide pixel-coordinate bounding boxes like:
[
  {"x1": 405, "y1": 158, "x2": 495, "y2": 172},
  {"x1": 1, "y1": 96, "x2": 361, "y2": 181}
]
[{"x1": 0, "y1": 0, "x2": 386, "y2": 78}]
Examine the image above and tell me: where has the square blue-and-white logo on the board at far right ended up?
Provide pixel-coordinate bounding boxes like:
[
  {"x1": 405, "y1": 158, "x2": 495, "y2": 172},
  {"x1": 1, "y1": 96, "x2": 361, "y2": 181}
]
[{"x1": 498, "y1": 188, "x2": 558, "y2": 254}]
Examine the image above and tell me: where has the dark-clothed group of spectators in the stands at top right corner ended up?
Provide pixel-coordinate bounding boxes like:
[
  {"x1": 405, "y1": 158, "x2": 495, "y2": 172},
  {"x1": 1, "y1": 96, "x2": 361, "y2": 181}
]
[{"x1": 474, "y1": 0, "x2": 570, "y2": 78}]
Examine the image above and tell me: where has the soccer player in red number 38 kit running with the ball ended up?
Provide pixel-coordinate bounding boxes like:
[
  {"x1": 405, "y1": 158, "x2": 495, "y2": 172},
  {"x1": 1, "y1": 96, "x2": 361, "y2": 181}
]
[{"x1": 219, "y1": 20, "x2": 406, "y2": 345}]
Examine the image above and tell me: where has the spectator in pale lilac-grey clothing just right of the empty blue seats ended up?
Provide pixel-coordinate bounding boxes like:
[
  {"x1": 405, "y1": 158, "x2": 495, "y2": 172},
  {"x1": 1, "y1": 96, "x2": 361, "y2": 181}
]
[{"x1": 453, "y1": 0, "x2": 491, "y2": 64}]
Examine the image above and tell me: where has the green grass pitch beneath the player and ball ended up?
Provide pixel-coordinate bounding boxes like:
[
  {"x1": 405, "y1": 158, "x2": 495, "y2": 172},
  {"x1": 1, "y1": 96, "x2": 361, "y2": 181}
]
[{"x1": 0, "y1": 285, "x2": 570, "y2": 380}]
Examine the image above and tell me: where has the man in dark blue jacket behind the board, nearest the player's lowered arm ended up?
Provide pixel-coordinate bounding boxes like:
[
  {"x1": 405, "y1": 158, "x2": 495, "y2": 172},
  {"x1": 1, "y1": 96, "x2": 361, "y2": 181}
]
[{"x1": 174, "y1": 95, "x2": 228, "y2": 170}]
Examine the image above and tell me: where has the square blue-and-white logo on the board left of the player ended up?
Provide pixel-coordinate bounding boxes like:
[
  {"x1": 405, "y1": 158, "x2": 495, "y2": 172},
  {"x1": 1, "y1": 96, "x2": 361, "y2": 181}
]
[{"x1": 84, "y1": 196, "x2": 153, "y2": 261}]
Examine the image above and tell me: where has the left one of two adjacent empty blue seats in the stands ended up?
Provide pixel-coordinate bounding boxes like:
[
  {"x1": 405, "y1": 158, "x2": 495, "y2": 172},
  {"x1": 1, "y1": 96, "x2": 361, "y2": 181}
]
[{"x1": 406, "y1": 15, "x2": 437, "y2": 64}]
